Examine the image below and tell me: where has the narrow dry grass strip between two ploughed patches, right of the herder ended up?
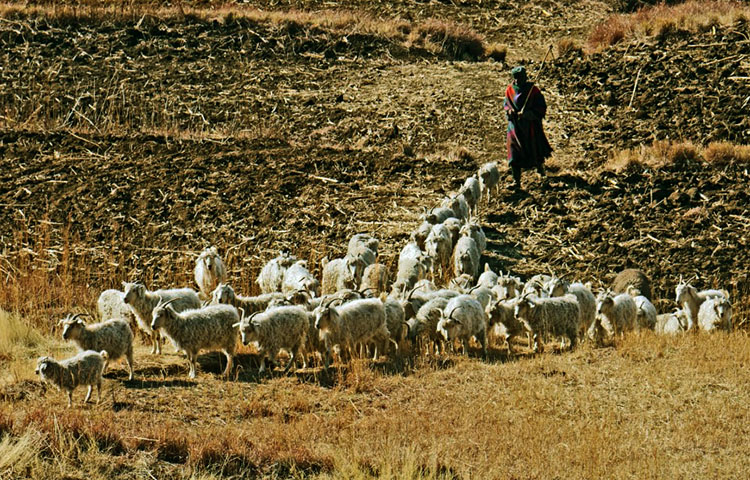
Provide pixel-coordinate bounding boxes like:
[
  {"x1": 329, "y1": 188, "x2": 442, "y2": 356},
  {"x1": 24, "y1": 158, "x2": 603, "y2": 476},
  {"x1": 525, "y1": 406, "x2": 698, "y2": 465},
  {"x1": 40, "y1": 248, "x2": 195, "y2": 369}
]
[{"x1": 604, "y1": 140, "x2": 750, "y2": 173}]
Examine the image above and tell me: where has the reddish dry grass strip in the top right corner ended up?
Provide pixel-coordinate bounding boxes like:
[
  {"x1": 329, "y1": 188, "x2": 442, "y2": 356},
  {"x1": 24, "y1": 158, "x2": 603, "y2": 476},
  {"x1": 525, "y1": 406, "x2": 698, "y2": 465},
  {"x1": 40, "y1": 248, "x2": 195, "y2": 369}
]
[{"x1": 588, "y1": 0, "x2": 750, "y2": 49}]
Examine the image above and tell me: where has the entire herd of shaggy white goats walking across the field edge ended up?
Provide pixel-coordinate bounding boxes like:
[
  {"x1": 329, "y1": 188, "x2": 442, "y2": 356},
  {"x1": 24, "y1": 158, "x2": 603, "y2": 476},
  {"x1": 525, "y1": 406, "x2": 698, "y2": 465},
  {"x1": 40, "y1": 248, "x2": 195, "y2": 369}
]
[{"x1": 36, "y1": 162, "x2": 732, "y2": 406}]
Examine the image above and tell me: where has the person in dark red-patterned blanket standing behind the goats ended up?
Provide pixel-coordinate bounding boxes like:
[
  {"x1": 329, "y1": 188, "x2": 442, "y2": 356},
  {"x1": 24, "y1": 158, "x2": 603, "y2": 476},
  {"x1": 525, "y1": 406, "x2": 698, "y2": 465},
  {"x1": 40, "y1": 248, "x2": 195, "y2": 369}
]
[{"x1": 503, "y1": 66, "x2": 552, "y2": 189}]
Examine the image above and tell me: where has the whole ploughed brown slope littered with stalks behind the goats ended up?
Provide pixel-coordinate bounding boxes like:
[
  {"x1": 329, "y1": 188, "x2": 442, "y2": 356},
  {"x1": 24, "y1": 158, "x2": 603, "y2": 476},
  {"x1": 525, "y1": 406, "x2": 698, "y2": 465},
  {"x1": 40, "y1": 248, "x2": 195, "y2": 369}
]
[{"x1": 0, "y1": 2, "x2": 750, "y2": 326}]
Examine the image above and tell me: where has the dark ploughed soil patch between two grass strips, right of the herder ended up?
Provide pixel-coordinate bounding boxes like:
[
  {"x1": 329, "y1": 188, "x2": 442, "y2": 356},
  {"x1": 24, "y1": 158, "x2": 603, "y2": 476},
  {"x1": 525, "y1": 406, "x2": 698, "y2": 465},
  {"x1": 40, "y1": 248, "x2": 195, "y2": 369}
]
[{"x1": 550, "y1": 22, "x2": 750, "y2": 152}]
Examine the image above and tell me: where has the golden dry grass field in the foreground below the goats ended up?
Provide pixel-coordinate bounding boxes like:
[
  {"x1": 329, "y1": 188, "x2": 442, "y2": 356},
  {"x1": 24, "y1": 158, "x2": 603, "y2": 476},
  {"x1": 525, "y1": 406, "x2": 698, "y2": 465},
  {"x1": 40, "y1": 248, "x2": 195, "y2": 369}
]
[{"x1": 0, "y1": 332, "x2": 750, "y2": 479}]
